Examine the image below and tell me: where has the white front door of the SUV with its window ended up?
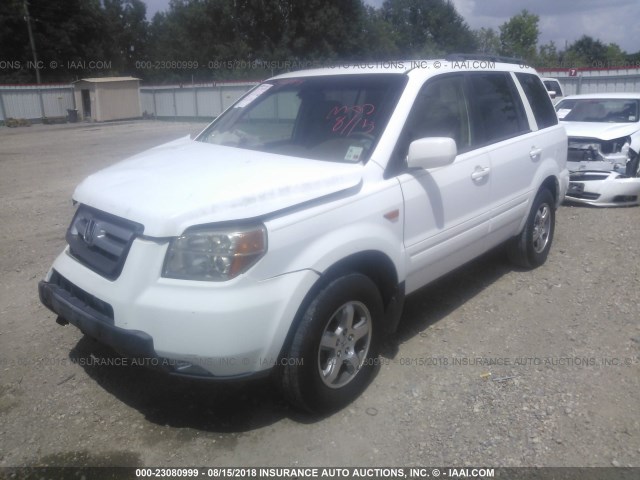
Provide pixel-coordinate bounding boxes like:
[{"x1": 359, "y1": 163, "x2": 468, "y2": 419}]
[{"x1": 398, "y1": 74, "x2": 492, "y2": 293}]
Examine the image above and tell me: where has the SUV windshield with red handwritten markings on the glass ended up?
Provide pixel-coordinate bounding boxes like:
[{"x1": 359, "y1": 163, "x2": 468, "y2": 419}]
[{"x1": 197, "y1": 74, "x2": 406, "y2": 163}]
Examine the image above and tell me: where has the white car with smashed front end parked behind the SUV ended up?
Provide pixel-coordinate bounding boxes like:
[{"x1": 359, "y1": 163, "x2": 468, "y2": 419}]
[{"x1": 556, "y1": 93, "x2": 640, "y2": 207}]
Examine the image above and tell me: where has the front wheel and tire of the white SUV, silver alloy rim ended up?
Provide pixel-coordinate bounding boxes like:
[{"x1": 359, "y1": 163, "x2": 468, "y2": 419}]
[{"x1": 278, "y1": 273, "x2": 383, "y2": 414}]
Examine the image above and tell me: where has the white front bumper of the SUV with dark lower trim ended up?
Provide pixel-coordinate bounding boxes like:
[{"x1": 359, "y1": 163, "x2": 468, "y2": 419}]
[{"x1": 39, "y1": 239, "x2": 318, "y2": 379}]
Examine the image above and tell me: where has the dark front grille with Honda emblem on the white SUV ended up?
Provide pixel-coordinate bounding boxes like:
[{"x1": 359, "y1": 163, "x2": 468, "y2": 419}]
[{"x1": 67, "y1": 205, "x2": 144, "y2": 280}]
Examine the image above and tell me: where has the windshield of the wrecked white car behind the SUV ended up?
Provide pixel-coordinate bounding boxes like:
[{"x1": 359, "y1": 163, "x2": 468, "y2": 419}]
[{"x1": 556, "y1": 98, "x2": 638, "y2": 123}]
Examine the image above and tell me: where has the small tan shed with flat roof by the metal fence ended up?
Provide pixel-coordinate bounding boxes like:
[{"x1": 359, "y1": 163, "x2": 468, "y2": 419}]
[{"x1": 73, "y1": 77, "x2": 142, "y2": 122}]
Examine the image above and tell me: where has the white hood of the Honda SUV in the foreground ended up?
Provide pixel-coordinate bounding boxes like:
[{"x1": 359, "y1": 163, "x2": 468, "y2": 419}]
[{"x1": 73, "y1": 137, "x2": 363, "y2": 237}]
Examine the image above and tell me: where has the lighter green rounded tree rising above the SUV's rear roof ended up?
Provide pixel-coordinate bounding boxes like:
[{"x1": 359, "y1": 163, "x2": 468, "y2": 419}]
[{"x1": 500, "y1": 10, "x2": 540, "y2": 63}]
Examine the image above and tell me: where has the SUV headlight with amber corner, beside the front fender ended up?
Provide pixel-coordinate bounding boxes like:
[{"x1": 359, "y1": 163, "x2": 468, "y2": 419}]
[{"x1": 162, "y1": 225, "x2": 267, "y2": 282}]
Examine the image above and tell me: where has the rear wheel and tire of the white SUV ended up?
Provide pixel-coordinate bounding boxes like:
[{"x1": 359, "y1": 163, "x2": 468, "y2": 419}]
[{"x1": 507, "y1": 188, "x2": 556, "y2": 269}]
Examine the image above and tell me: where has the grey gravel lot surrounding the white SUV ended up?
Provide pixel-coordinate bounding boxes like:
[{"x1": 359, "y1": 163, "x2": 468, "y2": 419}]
[{"x1": 0, "y1": 121, "x2": 640, "y2": 467}]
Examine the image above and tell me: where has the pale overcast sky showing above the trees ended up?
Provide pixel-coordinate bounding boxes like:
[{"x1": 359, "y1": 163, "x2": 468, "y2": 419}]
[{"x1": 145, "y1": 0, "x2": 640, "y2": 53}]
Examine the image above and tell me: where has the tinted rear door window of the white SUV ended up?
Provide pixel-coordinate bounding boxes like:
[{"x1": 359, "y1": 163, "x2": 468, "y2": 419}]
[{"x1": 468, "y1": 72, "x2": 528, "y2": 145}]
